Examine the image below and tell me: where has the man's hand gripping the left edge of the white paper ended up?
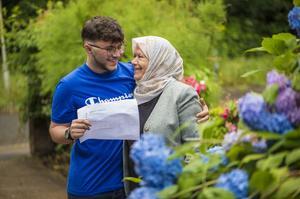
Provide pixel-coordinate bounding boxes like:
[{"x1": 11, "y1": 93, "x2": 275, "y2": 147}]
[{"x1": 70, "y1": 119, "x2": 91, "y2": 140}]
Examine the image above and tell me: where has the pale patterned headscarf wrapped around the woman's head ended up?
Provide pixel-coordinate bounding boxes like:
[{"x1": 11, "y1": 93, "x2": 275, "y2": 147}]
[{"x1": 132, "y1": 36, "x2": 183, "y2": 104}]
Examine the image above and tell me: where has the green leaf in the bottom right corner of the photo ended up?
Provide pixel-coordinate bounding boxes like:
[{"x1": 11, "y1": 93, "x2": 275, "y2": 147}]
[{"x1": 275, "y1": 178, "x2": 300, "y2": 199}]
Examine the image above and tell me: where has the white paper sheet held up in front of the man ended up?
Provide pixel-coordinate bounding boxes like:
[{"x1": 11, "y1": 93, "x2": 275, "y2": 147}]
[{"x1": 77, "y1": 99, "x2": 140, "y2": 143}]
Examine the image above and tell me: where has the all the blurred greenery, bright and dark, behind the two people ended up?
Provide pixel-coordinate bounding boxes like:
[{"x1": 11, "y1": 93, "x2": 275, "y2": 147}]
[{"x1": 0, "y1": 0, "x2": 293, "y2": 121}]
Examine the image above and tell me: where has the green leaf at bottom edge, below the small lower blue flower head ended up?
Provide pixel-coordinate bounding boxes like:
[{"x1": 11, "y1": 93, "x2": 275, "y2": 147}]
[{"x1": 197, "y1": 187, "x2": 235, "y2": 199}]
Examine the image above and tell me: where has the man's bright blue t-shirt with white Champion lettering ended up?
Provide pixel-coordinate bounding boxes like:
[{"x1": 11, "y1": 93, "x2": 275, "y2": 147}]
[{"x1": 51, "y1": 62, "x2": 135, "y2": 196}]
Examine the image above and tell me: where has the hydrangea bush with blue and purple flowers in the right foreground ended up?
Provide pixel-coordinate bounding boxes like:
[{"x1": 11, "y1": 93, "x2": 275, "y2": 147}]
[{"x1": 130, "y1": 3, "x2": 300, "y2": 199}]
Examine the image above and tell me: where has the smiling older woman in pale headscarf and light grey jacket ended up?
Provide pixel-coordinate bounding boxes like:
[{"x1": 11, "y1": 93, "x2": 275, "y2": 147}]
[{"x1": 125, "y1": 36, "x2": 202, "y2": 193}]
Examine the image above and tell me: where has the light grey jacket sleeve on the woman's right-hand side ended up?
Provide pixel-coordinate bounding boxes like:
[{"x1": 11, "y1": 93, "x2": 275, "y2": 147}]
[{"x1": 177, "y1": 86, "x2": 202, "y2": 142}]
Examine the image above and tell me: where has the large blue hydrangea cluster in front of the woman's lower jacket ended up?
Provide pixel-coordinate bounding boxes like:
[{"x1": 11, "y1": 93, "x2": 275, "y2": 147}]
[{"x1": 130, "y1": 133, "x2": 182, "y2": 199}]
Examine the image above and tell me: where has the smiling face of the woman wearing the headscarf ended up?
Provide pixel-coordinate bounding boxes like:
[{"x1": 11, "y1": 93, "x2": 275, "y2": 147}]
[{"x1": 131, "y1": 46, "x2": 149, "y2": 81}]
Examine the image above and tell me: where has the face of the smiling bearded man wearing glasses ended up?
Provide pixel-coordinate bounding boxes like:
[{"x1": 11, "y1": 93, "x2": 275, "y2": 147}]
[{"x1": 85, "y1": 40, "x2": 124, "y2": 72}]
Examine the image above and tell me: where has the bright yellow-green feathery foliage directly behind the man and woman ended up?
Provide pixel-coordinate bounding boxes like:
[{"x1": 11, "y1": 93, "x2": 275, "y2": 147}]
[{"x1": 12, "y1": 0, "x2": 225, "y2": 115}]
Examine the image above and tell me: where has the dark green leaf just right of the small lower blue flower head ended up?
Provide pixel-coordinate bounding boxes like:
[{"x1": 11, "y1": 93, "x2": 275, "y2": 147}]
[{"x1": 250, "y1": 171, "x2": 274, "y2": 192}]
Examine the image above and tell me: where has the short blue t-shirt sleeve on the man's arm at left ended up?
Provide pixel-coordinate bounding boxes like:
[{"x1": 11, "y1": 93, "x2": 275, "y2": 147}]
[{"x1": 51, "y1": 81, "x2": 77, "y2": 124}]
